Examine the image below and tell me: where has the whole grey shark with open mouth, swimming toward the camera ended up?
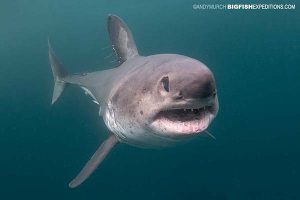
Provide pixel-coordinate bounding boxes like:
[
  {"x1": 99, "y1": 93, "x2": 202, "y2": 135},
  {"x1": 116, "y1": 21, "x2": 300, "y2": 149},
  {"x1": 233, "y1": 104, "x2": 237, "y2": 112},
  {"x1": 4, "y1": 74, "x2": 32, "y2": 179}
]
[{"x1": 48, "y1": 15, "x2": 219, "y2": 188}]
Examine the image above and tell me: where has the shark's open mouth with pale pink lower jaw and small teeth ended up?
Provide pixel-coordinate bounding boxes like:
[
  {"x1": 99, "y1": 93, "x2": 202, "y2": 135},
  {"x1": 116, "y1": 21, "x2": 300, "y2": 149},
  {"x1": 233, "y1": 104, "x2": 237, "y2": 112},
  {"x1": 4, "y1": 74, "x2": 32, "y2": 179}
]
[{"x1": 153, "y1": 106, "x2": 215, "y2": 135}]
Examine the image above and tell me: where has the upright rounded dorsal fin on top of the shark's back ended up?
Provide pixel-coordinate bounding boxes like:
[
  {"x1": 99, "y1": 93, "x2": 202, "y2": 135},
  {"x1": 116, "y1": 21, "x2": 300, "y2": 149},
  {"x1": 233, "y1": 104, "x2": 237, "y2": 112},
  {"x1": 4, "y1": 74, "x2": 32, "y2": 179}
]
[{"x1": 107, "y1": 15, "x2": 139, "y2": 63}]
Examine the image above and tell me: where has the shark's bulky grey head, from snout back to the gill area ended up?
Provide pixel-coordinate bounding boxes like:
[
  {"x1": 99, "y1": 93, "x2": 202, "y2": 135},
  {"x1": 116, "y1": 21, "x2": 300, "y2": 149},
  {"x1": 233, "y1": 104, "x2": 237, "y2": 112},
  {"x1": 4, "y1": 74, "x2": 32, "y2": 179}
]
[{"x1": 106, "y1": 54, "x2": 219, "y2": 145}]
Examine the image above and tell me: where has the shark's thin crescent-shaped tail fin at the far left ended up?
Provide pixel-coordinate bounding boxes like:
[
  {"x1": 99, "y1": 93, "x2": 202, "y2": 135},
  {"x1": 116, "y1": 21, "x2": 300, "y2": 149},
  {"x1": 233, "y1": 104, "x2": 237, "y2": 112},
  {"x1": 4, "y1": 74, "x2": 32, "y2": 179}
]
[{"x1": 48, "y1": 39, "x2": 68, "y2": 104}]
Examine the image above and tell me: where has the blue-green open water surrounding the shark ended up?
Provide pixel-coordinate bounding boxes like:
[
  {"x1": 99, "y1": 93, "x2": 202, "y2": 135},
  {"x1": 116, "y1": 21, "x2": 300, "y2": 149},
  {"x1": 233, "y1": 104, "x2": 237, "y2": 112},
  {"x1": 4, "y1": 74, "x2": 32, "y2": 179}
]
[{"x1": 0, "y1": 0, "x2": 300, "y2": 200}]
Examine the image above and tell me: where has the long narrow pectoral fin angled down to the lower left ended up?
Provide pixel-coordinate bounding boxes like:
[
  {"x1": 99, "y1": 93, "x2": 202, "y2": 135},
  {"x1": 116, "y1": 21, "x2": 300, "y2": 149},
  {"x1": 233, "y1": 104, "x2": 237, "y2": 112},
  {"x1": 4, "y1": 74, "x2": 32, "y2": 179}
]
[{"x1": 69, "y1": 134, "x2": 118, "y2": 188}]
